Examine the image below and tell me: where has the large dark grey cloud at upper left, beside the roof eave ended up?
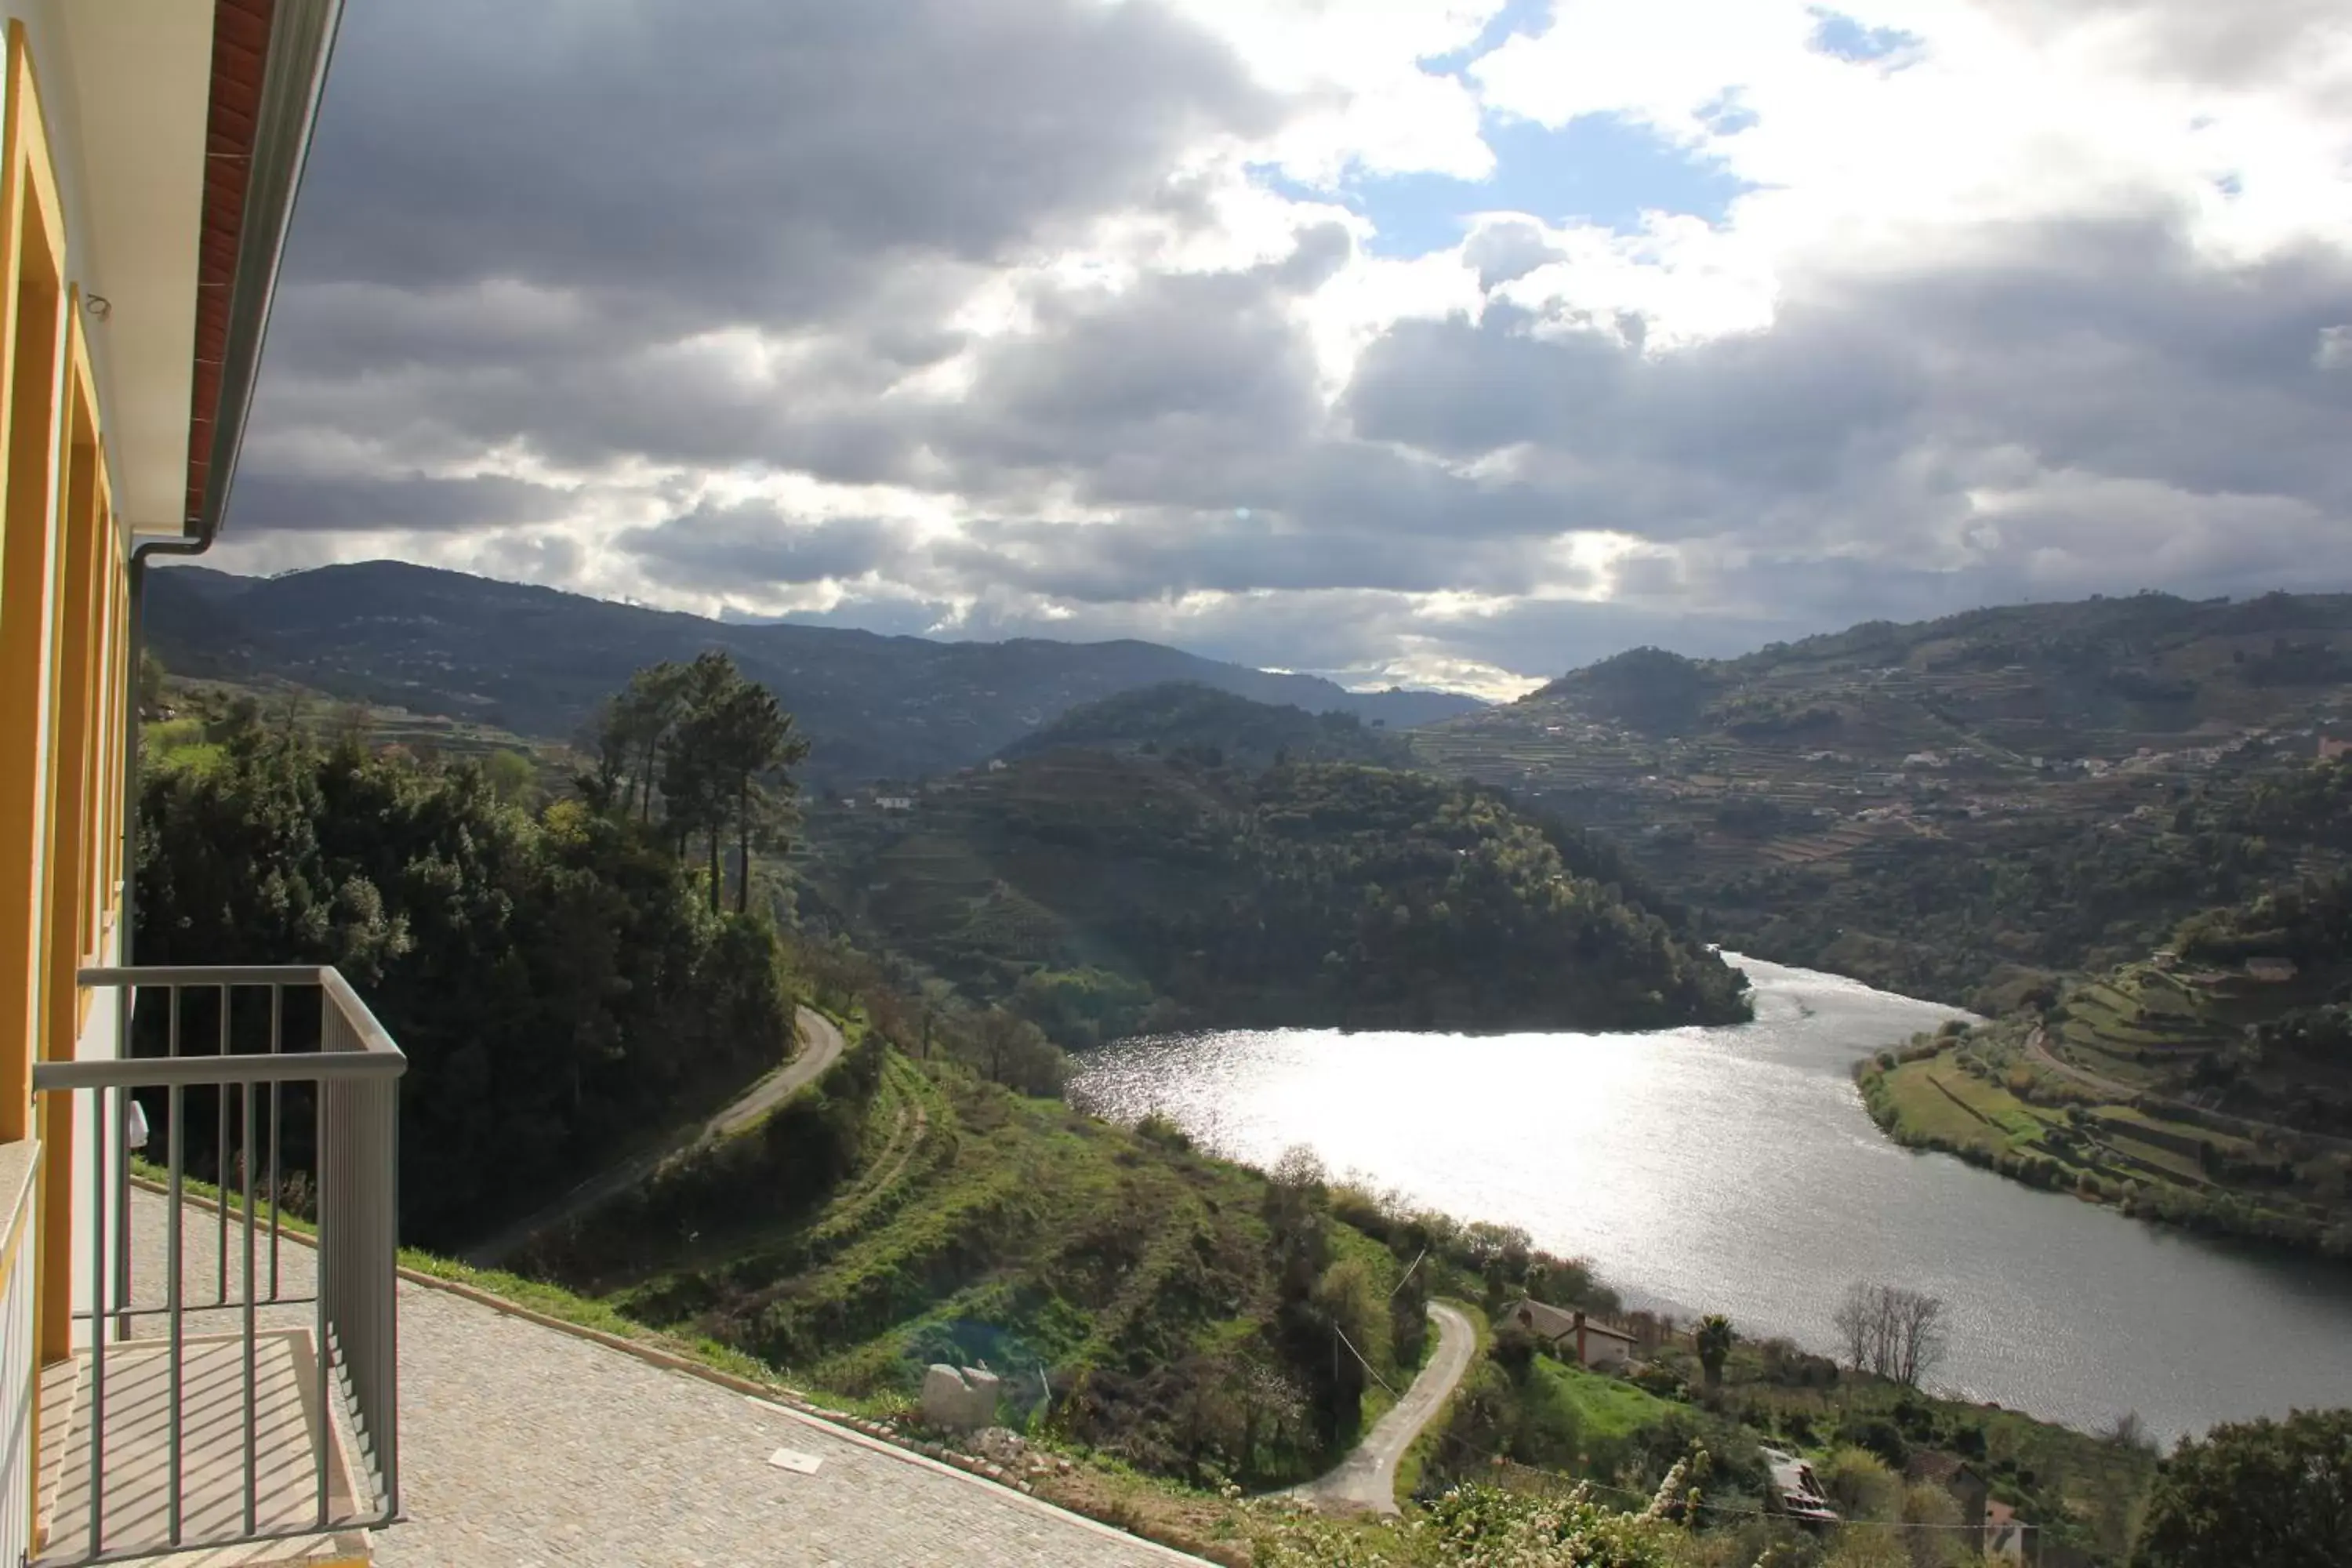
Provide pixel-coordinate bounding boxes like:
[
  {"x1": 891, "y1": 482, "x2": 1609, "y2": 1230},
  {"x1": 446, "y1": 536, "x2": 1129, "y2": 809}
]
[{"x1": 294, "y1": 0, "x2": 1275, "y2": 334}]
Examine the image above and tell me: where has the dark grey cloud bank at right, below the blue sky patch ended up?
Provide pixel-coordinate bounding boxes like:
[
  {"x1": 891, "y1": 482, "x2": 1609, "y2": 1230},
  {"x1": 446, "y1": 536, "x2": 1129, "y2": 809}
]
[{"x1": 1348, "y1": 205, "x2": 2352, "y2": 546}]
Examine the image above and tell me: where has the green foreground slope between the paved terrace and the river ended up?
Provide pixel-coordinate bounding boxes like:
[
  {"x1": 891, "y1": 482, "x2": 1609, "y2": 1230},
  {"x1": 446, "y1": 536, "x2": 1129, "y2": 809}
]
[{"x1": 529, "y1": 1032, "x2": 2154, "y2": 1568}]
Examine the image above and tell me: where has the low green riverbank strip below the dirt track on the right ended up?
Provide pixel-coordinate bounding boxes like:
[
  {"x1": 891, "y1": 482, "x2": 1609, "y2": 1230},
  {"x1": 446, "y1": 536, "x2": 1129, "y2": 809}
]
[{"x1": 1856, "y1": 1020, "x2": 2352, "y2": 1258}]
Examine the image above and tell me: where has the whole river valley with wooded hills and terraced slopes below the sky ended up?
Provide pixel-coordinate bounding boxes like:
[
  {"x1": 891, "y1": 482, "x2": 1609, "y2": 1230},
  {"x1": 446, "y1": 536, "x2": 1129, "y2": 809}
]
[{"x1": 124, "y1": 569, "x2": 2352, "y2": 1561}]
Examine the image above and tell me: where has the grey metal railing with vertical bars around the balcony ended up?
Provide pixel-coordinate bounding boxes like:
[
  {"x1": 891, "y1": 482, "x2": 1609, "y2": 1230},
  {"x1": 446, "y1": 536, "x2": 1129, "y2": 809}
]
[{"x1": 33, "y1": 966, "x2": 407, "y2": 1561}]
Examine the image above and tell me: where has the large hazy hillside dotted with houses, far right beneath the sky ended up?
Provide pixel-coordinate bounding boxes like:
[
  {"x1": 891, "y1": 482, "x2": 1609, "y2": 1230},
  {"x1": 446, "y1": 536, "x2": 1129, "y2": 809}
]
[{"x1": 1409, "y1": 595, "x2": 2352, "y2": 1006}]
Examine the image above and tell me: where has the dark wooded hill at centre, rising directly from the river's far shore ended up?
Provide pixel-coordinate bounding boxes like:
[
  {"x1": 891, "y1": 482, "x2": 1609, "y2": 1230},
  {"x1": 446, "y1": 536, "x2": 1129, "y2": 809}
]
[{"x1": 802, "y1": 748, "x2": 1745, "y2": 1044}]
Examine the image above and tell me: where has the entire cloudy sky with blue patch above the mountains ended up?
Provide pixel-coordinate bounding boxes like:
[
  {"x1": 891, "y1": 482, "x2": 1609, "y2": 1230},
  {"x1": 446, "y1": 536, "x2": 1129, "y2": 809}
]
[{"x1": 219, "y1": 0, "x2": 2352, "y2": 694}]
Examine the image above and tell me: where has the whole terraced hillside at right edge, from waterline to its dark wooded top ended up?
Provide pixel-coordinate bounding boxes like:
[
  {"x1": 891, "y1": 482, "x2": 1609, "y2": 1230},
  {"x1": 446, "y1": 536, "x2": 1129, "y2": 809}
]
[{"x1": 1863, "y1": 874, "x2": 2352, "y2": 1255}]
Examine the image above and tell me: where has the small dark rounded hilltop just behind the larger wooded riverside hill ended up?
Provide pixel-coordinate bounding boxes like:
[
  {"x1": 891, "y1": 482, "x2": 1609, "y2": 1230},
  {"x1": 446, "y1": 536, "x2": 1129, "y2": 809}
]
[{"x1": 1004, "y1": 682, "x2": 1414, "y2": 769}]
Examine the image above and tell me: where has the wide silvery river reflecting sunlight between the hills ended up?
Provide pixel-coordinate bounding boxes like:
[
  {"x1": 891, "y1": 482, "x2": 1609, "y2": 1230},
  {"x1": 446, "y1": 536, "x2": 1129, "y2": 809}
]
[{"x1": 1070, "y1": 959, "x2": 2352, "y2": 1436}]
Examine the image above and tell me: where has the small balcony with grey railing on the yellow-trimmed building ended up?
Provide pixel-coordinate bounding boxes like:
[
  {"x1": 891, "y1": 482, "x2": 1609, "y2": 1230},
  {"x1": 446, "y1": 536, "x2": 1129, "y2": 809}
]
[{"x1": 33, "y1": 966, "x2": 407, "y2": 1566}]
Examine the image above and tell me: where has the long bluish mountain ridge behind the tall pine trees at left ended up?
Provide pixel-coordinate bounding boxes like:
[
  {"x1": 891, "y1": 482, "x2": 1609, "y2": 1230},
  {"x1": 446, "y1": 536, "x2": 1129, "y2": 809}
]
[{"x1": 146, "y1": 562, "x2": 1479, "y2": 783}]
